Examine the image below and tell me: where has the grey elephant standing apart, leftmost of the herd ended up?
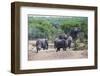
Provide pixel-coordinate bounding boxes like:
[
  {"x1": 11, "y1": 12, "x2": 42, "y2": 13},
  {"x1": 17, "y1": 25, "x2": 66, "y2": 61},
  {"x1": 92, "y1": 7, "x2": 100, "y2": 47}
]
[{"x1": 36, "y1": 39, "x2": 48, "y2": 53}]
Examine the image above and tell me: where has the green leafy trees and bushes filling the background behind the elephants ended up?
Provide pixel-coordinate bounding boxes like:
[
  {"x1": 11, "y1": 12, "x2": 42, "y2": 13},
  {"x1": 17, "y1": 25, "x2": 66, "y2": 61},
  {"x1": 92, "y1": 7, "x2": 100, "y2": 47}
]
[{"x1": 28, "y1": 15, "x2": 88, "y2": 41}]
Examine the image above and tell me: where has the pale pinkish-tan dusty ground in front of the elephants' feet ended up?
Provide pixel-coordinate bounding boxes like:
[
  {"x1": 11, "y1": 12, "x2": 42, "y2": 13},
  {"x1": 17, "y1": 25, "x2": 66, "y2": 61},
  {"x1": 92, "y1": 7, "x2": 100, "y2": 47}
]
[{"x1": 28, "y1": 50, "x2": 88, "y2": 60}]
